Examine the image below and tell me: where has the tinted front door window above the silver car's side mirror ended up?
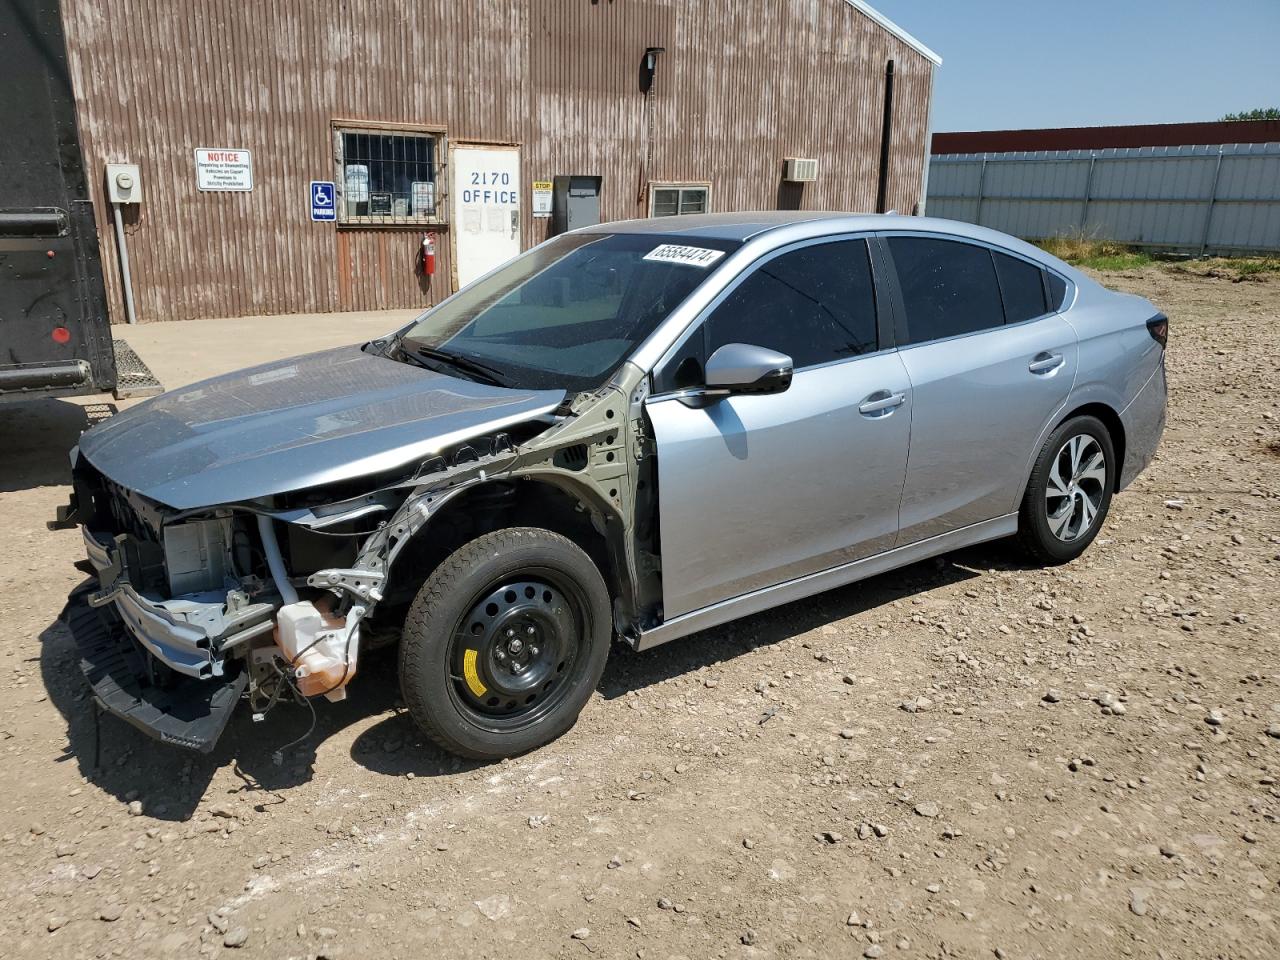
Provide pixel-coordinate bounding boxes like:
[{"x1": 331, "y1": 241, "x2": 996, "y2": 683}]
[{"x1": 707, "y1": 239, "x2": 877, "y2": 367}]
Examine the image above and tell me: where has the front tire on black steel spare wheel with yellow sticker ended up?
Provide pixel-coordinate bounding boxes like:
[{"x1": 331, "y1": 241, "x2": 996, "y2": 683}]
[{"x1": 399, "y1": 527, "x2": 613, "y2": 760}]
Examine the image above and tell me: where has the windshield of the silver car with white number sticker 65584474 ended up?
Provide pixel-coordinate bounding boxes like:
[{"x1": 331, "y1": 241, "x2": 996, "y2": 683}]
[{"x1": 399, "y1": 233, "x2": 739, "y2": 390}]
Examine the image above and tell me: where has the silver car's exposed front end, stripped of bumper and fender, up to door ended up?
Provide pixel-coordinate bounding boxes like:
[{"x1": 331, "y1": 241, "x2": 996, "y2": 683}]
[{"x1": 50, "y1": 365, "x2": 658, "y2": 751}]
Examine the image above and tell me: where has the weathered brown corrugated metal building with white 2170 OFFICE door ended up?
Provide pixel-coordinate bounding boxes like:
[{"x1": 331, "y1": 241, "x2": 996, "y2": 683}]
[{"x1": 63, "y1": 0, "x2": 938, "y2": 321}]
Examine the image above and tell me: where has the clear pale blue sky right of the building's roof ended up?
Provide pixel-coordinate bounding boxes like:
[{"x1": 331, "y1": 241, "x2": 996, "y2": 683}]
[{"x1": 870, "y1": 0, "x2": 1280, "y2": 132}]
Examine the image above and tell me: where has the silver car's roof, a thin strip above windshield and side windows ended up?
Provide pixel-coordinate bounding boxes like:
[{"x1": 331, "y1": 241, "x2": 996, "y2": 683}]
[{"x1": 581, "y1": 210, "x2": 1074, "y2": 273}]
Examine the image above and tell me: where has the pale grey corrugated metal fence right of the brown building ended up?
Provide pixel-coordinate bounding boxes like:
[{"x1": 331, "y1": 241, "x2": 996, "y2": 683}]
[{"x1": 928, "y1": 143, "x2": 1280, "y2": 253}]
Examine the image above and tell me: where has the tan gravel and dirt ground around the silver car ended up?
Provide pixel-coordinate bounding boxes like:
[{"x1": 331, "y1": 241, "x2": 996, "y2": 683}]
[{"x1": 0, "y1": 268, "x2": 1280, "y2": 960}]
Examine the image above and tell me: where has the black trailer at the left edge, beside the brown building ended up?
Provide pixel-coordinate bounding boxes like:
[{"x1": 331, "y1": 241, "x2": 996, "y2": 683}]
[{"x1": 0, "y1": 0, "x2": 160, "y2": 403}]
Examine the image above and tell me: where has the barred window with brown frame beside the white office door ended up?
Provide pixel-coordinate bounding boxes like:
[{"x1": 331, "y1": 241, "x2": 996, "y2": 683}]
[{"x1": 334, "y1": 127, "x2": 445, "y2": 225}]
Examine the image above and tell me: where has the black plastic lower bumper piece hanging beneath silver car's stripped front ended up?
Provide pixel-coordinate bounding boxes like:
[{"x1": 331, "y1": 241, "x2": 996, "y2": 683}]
[{"x1": 67, "y1": 589, "x2": 248, "y2": 753}]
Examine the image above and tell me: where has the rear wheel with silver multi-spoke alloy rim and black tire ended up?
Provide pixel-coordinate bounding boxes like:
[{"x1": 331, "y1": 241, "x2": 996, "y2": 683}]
[{"x1": 1018, "y1": 416, "x2": 1119, "y2": 564}]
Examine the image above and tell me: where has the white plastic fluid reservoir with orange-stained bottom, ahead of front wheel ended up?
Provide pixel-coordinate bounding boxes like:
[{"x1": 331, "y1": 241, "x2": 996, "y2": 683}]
[{"x1": 275, "y1": 600, "x2": 360, "y2": 700}]
